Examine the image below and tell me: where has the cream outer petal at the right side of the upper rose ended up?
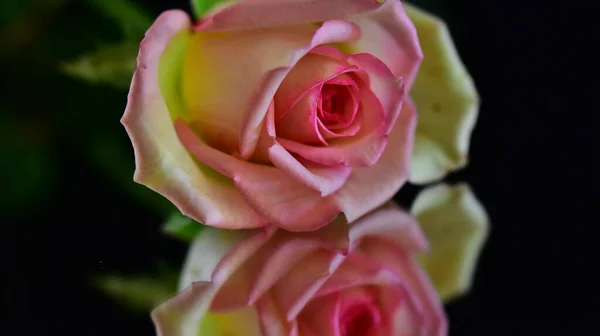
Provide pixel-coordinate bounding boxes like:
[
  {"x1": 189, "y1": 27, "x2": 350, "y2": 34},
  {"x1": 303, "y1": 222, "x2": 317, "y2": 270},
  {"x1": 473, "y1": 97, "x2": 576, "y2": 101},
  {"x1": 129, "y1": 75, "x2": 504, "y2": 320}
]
[{"x1": 404, "y1": 3, "x2": 479, "y2": 184}]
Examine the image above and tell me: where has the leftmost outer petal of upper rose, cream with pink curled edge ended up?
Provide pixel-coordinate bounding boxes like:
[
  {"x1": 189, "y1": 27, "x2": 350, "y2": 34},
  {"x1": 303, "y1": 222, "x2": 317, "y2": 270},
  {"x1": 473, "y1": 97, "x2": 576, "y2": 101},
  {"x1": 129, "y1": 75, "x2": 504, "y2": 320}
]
[{"x1": 121, "y1": 10, "x2": 266, "y2": 228}]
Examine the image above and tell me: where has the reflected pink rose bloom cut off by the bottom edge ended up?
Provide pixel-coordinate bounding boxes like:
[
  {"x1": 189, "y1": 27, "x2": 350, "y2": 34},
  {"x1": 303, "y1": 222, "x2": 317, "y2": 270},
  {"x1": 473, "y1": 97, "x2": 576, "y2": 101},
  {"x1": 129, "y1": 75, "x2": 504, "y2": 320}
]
[{"x1": 152, "y1": 204, "x2": 447, "y2": 336}]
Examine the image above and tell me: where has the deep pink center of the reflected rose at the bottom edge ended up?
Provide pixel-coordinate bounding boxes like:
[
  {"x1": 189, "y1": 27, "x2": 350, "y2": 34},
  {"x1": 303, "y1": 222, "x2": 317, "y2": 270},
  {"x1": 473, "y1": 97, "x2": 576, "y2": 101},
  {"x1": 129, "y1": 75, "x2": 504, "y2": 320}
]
[{"x1": 340, "y1": 303, "x2": 381, "y2": 336}]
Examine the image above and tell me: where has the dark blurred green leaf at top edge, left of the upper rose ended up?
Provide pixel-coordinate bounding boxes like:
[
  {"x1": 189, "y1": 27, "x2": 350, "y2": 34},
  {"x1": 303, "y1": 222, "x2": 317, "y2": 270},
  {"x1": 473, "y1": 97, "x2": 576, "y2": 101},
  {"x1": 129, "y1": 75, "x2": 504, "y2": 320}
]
[{"x1": 86, "y1": 0, "x2": 152, "y2": 42}]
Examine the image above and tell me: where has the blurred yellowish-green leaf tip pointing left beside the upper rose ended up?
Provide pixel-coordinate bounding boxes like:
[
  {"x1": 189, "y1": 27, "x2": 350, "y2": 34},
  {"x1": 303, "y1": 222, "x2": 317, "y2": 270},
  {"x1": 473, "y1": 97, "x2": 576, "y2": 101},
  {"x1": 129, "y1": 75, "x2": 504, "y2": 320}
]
[{"x1": 61, "y1": 43, "x2": 139, "y2": 89}]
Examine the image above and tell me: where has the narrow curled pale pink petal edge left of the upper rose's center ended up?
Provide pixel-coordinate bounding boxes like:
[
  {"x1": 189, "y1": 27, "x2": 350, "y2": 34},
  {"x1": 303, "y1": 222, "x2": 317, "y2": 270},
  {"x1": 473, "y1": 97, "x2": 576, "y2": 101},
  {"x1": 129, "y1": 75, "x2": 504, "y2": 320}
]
[{"x1": 238, "y1": 20, "x2": 359, "y2": 158}]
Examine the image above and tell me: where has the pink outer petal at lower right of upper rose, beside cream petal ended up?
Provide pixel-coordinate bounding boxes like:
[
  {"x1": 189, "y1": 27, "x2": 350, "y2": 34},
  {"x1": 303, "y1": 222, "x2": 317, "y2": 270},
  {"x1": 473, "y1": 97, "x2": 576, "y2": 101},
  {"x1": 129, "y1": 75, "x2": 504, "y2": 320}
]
[{"x1": 333, "y1": 97, "x2": 417, "y2": 222}]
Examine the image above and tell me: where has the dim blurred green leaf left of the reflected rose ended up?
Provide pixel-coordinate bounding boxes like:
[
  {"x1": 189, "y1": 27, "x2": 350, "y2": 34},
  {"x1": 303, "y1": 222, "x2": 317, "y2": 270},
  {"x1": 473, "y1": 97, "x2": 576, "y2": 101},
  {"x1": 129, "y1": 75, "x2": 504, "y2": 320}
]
[{"x1": 93, "y1": 273, "x2": 177, "y2": 313}]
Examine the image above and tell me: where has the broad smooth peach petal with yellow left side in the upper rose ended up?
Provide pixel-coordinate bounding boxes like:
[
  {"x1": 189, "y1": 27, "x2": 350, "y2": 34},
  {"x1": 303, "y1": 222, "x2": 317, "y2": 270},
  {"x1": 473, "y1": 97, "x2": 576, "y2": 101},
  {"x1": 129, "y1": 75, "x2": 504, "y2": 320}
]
[{"x1": 182, "y1": 25, "x2": 317, "y2": 153}]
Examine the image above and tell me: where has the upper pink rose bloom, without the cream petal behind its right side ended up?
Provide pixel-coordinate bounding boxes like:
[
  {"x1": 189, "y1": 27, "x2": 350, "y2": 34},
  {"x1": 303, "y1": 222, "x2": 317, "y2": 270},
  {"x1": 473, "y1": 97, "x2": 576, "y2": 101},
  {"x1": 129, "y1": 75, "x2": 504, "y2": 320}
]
[{"x1": 122, "y1": 0, "x2": 422, "y2": 231}]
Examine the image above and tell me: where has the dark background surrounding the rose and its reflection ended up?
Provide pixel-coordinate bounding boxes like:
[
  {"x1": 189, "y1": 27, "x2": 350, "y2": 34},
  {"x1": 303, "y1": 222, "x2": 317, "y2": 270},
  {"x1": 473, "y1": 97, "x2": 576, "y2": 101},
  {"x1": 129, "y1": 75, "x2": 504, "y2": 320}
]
[{"x1": 0, "y1": 0, "x2": 600, "y2": 336}]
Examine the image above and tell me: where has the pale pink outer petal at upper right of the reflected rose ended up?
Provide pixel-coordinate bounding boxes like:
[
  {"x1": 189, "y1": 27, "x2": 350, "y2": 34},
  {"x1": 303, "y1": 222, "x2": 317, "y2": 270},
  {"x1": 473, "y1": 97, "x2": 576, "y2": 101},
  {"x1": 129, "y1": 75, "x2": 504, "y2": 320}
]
[{"x1": 349, "y1": 202, "x2": 428, "y2": 252}]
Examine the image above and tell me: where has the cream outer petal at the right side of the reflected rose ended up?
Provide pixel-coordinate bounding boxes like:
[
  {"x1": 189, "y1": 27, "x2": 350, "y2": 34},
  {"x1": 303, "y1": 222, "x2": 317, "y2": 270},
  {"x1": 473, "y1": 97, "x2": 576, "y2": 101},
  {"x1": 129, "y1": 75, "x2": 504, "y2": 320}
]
[{"x1": 412, "y1": 184, "x2": 489, "y2": 301}]
